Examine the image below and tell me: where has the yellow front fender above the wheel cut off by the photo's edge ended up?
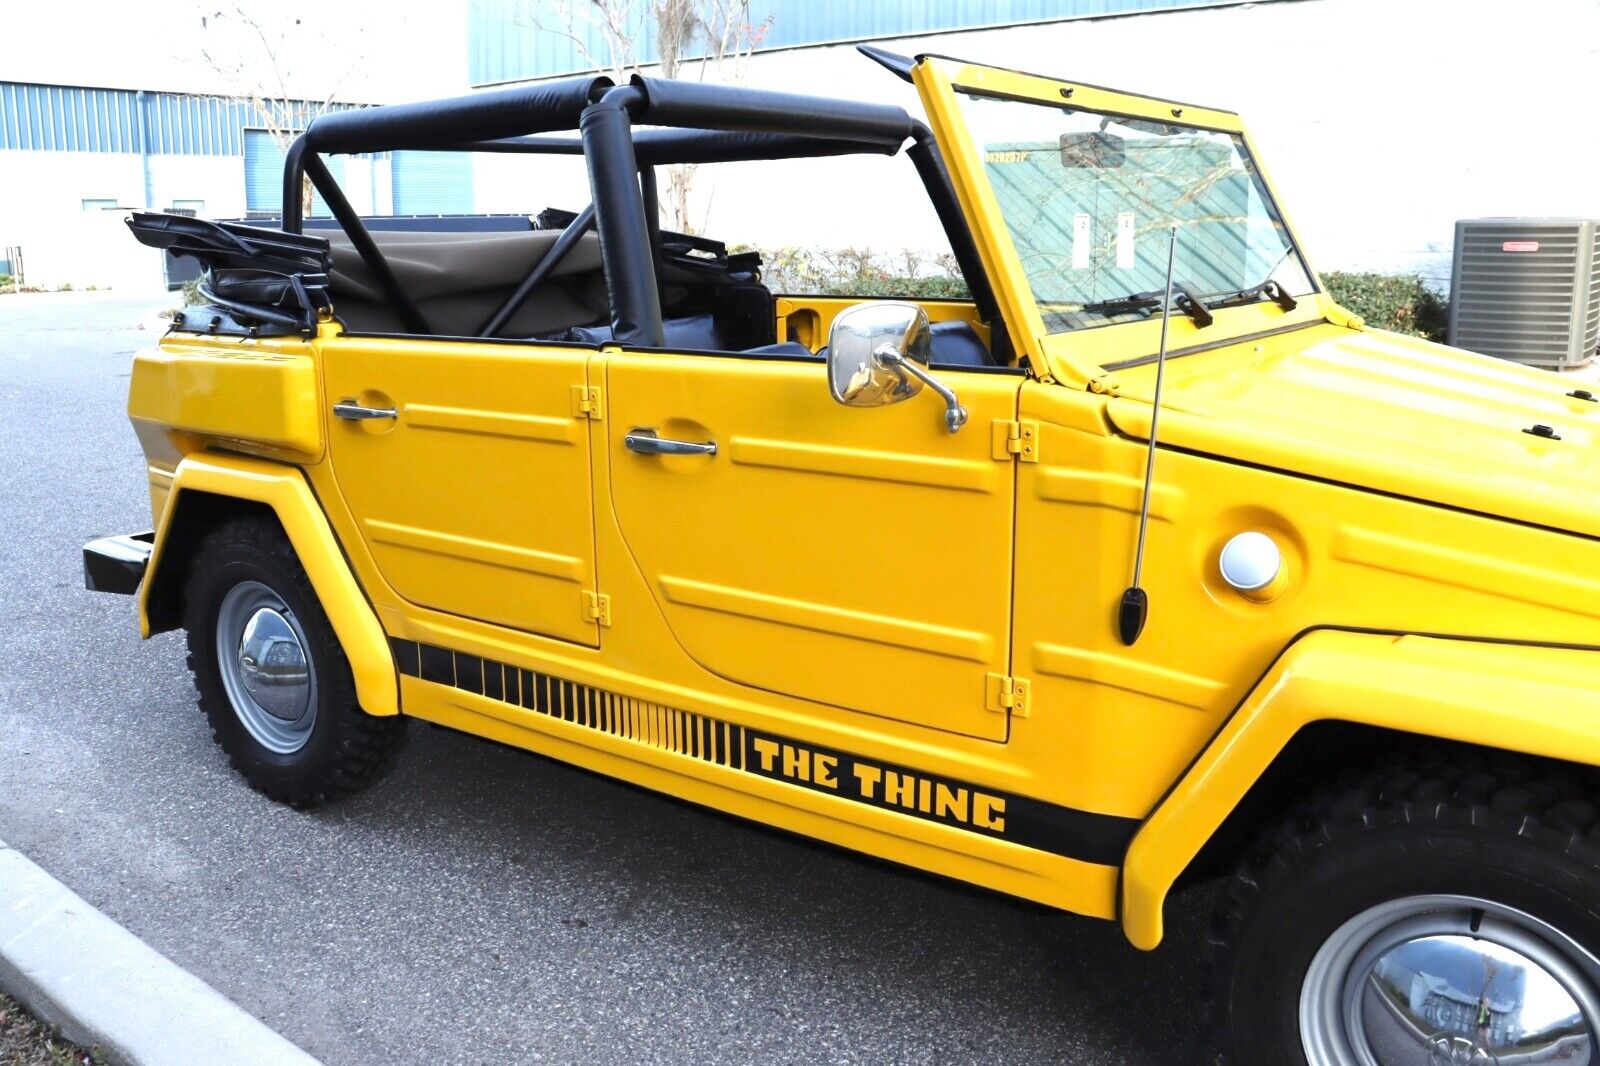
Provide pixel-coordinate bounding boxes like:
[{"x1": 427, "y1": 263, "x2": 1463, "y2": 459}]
[{"x1": 1122, "y1": 629, "x2": 1600, "y2": 951}]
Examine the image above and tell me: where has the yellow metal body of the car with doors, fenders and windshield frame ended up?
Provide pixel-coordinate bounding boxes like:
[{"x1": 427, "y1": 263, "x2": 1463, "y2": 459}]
[{"x1": 109, "y1": 59, "x2": 1600, "y2": 949}]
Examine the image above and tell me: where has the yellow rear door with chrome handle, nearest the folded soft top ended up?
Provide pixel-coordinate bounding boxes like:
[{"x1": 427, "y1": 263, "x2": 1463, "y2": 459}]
[{"x1": 320, "y1": 336, "x2": 600, "y2": 645}]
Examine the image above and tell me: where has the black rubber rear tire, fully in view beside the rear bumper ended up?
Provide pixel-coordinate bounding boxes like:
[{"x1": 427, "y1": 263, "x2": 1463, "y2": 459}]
[{"x1": 184, "y1": 519, "x2": 406, "y2": 807}]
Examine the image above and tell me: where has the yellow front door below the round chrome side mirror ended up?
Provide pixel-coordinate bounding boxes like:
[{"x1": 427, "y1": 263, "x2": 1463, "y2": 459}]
[{"x1": 605, "y1": 352, "x2": 1021, "y2": 741}]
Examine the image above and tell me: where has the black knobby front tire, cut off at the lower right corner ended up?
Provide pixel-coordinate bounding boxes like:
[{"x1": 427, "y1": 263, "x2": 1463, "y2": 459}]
[{"x1": 1211, "y1": 752, "x2": 1600, "y2": 1066}]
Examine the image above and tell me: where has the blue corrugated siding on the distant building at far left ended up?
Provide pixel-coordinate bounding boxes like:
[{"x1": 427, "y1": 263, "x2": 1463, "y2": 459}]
[{"x1": 0, "y1": 82, "x2": 364, "y2": 155}]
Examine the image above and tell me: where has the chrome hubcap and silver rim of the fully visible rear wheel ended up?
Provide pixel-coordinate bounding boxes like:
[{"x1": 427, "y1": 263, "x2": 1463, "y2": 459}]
[{"x1": 216, "y1": 581, "x2": 317, "y2": 745}]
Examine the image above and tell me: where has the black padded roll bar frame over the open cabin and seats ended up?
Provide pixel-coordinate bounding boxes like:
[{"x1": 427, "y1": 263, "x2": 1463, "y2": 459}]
[{"x1": 273, "y1": 65, "x2": 1003, "y2": 347}]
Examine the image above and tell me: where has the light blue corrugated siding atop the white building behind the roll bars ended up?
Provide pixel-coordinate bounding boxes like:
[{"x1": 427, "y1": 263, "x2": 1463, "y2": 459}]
[{"x1": 467, "y1": 0, "x2": 1269, "y2": 85}]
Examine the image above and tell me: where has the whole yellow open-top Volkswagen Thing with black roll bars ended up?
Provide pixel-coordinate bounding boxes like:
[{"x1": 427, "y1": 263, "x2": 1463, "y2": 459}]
[{"x1": 85, "y1": 50, "x2": 1600, "y2": 1066}]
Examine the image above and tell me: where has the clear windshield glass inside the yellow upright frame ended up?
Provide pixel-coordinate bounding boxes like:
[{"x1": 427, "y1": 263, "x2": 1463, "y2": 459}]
[{"x1": 958, "y1": 93, "x2": 1314, "y2": 333}]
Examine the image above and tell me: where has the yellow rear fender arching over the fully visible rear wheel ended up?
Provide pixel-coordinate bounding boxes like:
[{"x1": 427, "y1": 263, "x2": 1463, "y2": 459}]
[{"x1": 139, "y1": 453, "x2": 400, "y2": 715}]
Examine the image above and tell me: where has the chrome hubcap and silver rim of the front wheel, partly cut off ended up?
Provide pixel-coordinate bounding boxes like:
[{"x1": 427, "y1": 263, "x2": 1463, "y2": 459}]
[{"x1": 1299, "y1": 896, "x2": 1600, "y2": 1066}]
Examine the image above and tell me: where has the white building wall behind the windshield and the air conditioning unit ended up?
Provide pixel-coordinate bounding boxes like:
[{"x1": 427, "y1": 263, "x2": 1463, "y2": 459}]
[{"x1": 477, "y1": 0, "x2": 1600, "y2": 288}]
